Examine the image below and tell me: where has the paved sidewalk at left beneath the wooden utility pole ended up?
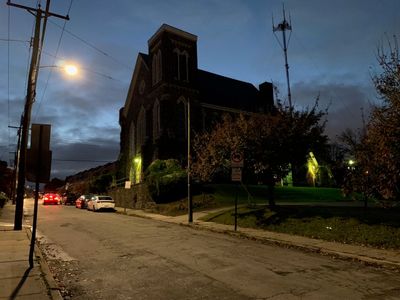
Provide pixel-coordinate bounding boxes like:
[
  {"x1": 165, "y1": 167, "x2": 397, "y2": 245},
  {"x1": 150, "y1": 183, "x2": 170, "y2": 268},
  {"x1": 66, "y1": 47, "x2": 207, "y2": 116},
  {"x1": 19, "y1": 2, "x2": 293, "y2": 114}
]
[{"x1": 0, "y1": 203, "x2": 62, "y2": 300}]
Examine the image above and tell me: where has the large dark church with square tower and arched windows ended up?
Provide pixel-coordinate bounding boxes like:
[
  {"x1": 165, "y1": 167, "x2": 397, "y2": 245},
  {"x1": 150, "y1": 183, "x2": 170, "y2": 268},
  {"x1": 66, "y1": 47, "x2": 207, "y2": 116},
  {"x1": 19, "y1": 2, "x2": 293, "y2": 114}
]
[{"x1": 119, "y1": 24, "x2": 274, "y2": 182}]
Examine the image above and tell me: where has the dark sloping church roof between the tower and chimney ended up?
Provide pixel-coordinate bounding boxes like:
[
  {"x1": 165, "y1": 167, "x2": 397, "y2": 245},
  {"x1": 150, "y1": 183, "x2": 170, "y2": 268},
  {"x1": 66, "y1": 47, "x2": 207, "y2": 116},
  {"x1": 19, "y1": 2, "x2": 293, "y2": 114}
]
[{"x1": 196, "y1": 70, "x2": 258, "y2": 111}]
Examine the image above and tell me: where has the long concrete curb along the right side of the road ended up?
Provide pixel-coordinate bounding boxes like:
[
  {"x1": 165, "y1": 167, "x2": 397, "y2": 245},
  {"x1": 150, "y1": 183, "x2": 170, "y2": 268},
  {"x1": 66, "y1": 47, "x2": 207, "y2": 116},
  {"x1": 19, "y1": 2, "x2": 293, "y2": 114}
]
[{"x1": 118, "y1": 210, "x2": 400, "y2": 271}]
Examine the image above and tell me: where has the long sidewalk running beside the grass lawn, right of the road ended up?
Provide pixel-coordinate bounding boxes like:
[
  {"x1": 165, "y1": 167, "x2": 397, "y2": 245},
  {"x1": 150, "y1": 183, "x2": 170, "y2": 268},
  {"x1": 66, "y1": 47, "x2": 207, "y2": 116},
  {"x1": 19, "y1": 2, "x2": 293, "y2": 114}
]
[{"x1": 116, "y1": 207, "x2": 400, "y2": 270}]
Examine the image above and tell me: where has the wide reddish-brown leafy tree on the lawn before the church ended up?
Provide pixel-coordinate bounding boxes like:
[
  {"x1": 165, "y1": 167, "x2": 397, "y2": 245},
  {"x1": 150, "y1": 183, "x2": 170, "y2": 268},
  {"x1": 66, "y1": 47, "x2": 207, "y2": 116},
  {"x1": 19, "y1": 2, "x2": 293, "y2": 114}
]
[{"x1": 193, "y1": 102, "x2": 327, "y2": 206}]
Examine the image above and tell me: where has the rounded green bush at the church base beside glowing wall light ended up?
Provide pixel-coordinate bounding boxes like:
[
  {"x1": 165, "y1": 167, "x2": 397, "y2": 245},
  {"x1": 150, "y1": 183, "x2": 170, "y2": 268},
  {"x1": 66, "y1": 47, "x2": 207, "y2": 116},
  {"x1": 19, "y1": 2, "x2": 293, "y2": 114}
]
[{"x1": 145, "y1": 159, "x2": 187, "y2": 203}]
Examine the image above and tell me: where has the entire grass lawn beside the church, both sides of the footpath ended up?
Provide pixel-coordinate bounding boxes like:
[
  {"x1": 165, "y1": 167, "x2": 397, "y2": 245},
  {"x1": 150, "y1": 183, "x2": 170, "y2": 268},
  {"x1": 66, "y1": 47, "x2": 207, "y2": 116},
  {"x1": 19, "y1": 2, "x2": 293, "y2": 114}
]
[{"x1": 148, "y1": 184, "x2": 400, "y2": 249}]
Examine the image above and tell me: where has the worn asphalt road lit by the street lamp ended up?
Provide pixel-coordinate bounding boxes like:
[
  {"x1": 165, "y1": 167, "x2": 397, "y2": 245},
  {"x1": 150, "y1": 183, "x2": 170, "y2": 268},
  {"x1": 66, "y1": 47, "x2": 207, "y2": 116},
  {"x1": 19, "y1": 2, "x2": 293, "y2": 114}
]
[{"x1": 25, "y1": 200, "x2": 400, "y2": 299}]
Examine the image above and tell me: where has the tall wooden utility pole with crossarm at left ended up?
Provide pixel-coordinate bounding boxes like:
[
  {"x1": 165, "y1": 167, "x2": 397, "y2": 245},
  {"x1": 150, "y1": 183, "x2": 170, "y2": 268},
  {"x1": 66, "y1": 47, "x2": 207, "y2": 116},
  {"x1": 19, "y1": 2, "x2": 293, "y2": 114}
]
[{"x1": 7, "y1": 0, "x2": 69, "y2": 230}]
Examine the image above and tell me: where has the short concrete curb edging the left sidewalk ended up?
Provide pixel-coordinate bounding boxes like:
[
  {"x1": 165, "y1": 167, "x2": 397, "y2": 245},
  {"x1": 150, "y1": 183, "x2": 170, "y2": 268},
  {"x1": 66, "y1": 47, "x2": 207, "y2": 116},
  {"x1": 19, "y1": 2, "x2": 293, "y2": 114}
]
[{"x1": 24, "y1": 220, "x2": 63, "y2": 300}]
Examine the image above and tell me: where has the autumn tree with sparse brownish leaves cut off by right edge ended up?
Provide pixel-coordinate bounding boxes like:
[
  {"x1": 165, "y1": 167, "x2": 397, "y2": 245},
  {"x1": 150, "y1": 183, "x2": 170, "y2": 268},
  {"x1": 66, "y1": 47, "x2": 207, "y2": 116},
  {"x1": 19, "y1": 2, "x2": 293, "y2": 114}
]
[{"x1": 345, "y1": 39, "x2": 400, "y2": 205}]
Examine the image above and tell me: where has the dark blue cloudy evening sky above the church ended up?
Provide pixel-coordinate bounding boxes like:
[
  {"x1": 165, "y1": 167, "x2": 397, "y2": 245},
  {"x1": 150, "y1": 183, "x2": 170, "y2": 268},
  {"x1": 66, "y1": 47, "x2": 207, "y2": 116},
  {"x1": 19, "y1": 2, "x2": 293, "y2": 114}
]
[{"x1": 0, "y1": 0, "x2": 400, "y2": 178}]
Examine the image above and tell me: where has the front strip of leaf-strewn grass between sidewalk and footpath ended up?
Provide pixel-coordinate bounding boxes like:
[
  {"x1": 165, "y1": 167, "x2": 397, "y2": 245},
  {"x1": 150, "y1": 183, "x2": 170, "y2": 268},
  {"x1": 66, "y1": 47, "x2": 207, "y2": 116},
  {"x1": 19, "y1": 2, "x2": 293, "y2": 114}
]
[{"x1": 204, "y1": 205, "x2": 400, "y2": 249}]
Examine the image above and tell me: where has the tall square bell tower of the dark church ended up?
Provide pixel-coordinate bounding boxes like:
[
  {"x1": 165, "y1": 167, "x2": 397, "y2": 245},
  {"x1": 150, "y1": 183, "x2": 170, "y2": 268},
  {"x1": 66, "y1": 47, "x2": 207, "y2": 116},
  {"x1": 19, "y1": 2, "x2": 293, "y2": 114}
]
[{"x1": 147, "y1": 24, "x2": 198, "y2": 163}]
